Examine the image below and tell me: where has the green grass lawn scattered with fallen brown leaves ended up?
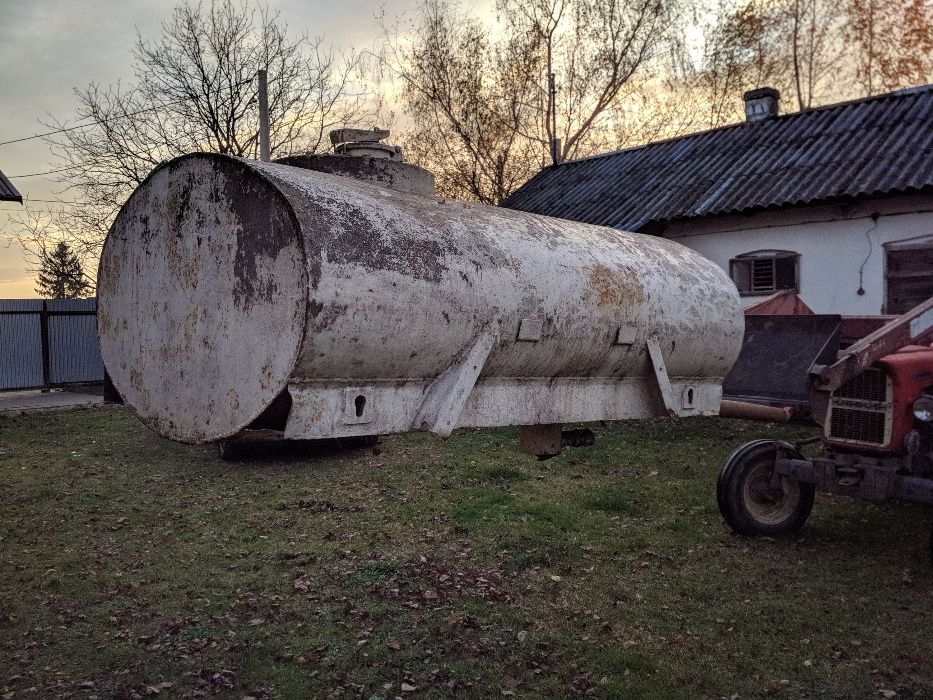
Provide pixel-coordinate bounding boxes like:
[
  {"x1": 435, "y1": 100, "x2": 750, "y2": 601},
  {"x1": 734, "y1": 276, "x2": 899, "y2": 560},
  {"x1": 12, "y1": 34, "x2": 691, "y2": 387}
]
[{"x1": 0, "y1": 409, "x2": 933, "y2": 698}]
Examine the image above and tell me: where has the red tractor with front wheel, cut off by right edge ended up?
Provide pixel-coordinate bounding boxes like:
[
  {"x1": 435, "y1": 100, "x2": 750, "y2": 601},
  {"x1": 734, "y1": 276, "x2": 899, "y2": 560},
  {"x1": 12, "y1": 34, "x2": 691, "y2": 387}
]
[{"x1": 716, "y1": 298, "x2": 933, "y2": 553}]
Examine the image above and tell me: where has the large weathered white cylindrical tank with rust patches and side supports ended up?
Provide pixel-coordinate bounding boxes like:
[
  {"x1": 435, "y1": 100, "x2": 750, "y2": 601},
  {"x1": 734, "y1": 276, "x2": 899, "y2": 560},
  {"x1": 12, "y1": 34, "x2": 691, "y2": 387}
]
[{"x1": 98, "y1": 148, "x2": 743, "y2": 443}]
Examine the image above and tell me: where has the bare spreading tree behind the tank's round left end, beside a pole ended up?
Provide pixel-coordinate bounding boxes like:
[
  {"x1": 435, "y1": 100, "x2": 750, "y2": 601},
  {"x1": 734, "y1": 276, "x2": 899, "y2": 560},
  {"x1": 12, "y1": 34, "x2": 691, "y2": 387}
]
[{"x1": 15, "y1": 0, "x2": 365, "y2": 270}]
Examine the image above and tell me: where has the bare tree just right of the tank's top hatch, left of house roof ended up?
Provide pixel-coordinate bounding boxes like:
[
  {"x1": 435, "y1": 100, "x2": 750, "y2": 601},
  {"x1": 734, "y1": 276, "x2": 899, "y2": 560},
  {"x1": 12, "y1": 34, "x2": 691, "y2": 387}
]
[{"x1": 380, "y1": 0, "x2": 543, "y2": 204}]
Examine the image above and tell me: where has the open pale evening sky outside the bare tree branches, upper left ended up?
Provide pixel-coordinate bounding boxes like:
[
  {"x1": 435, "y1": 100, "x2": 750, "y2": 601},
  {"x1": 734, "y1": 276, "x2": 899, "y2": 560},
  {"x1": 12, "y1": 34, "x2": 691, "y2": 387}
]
[{"x1": 0, "y1": 0, "x2": 480, "y2": 298}]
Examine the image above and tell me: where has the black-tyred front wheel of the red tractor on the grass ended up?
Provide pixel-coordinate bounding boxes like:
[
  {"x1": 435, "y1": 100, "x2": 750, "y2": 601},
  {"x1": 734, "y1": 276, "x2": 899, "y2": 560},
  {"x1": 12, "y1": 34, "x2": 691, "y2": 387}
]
[{"x1": 716, "y1": 440, "x2": 816, "y2": 535}]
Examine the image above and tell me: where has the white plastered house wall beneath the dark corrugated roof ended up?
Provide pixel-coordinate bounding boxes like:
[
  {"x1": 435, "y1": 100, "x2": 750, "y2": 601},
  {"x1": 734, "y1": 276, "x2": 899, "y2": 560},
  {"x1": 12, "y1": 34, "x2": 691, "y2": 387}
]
[{"x1": 662, "y1": 195, "x2": 933, "y2": 315}]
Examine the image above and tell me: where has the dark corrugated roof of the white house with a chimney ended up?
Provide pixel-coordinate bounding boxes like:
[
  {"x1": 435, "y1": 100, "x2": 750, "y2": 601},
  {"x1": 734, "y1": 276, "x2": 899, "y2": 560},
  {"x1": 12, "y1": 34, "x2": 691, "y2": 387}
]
[{"x1": 502, "y1": 85, "x2": 933, "y2": 231}]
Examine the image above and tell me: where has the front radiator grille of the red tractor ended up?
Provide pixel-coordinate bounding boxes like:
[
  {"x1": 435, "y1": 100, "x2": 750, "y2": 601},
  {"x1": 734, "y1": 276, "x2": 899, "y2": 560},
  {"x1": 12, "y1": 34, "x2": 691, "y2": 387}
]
[{"x1": 824, "y1": 367, "x2": 891, "y2": 447}]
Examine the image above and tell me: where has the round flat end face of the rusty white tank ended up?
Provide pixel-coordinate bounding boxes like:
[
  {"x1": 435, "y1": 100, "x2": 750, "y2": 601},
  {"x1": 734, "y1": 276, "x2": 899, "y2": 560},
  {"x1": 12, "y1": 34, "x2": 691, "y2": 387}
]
[{"x1": 98, "y1": 154, "x2": 307, "y2": 443}]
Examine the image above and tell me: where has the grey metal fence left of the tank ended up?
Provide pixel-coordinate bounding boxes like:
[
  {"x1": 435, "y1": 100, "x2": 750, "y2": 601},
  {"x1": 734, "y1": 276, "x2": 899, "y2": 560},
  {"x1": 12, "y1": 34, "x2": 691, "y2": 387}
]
[{"x1": 0, "y1": 299, "x2": 104, "y2": 390}]
